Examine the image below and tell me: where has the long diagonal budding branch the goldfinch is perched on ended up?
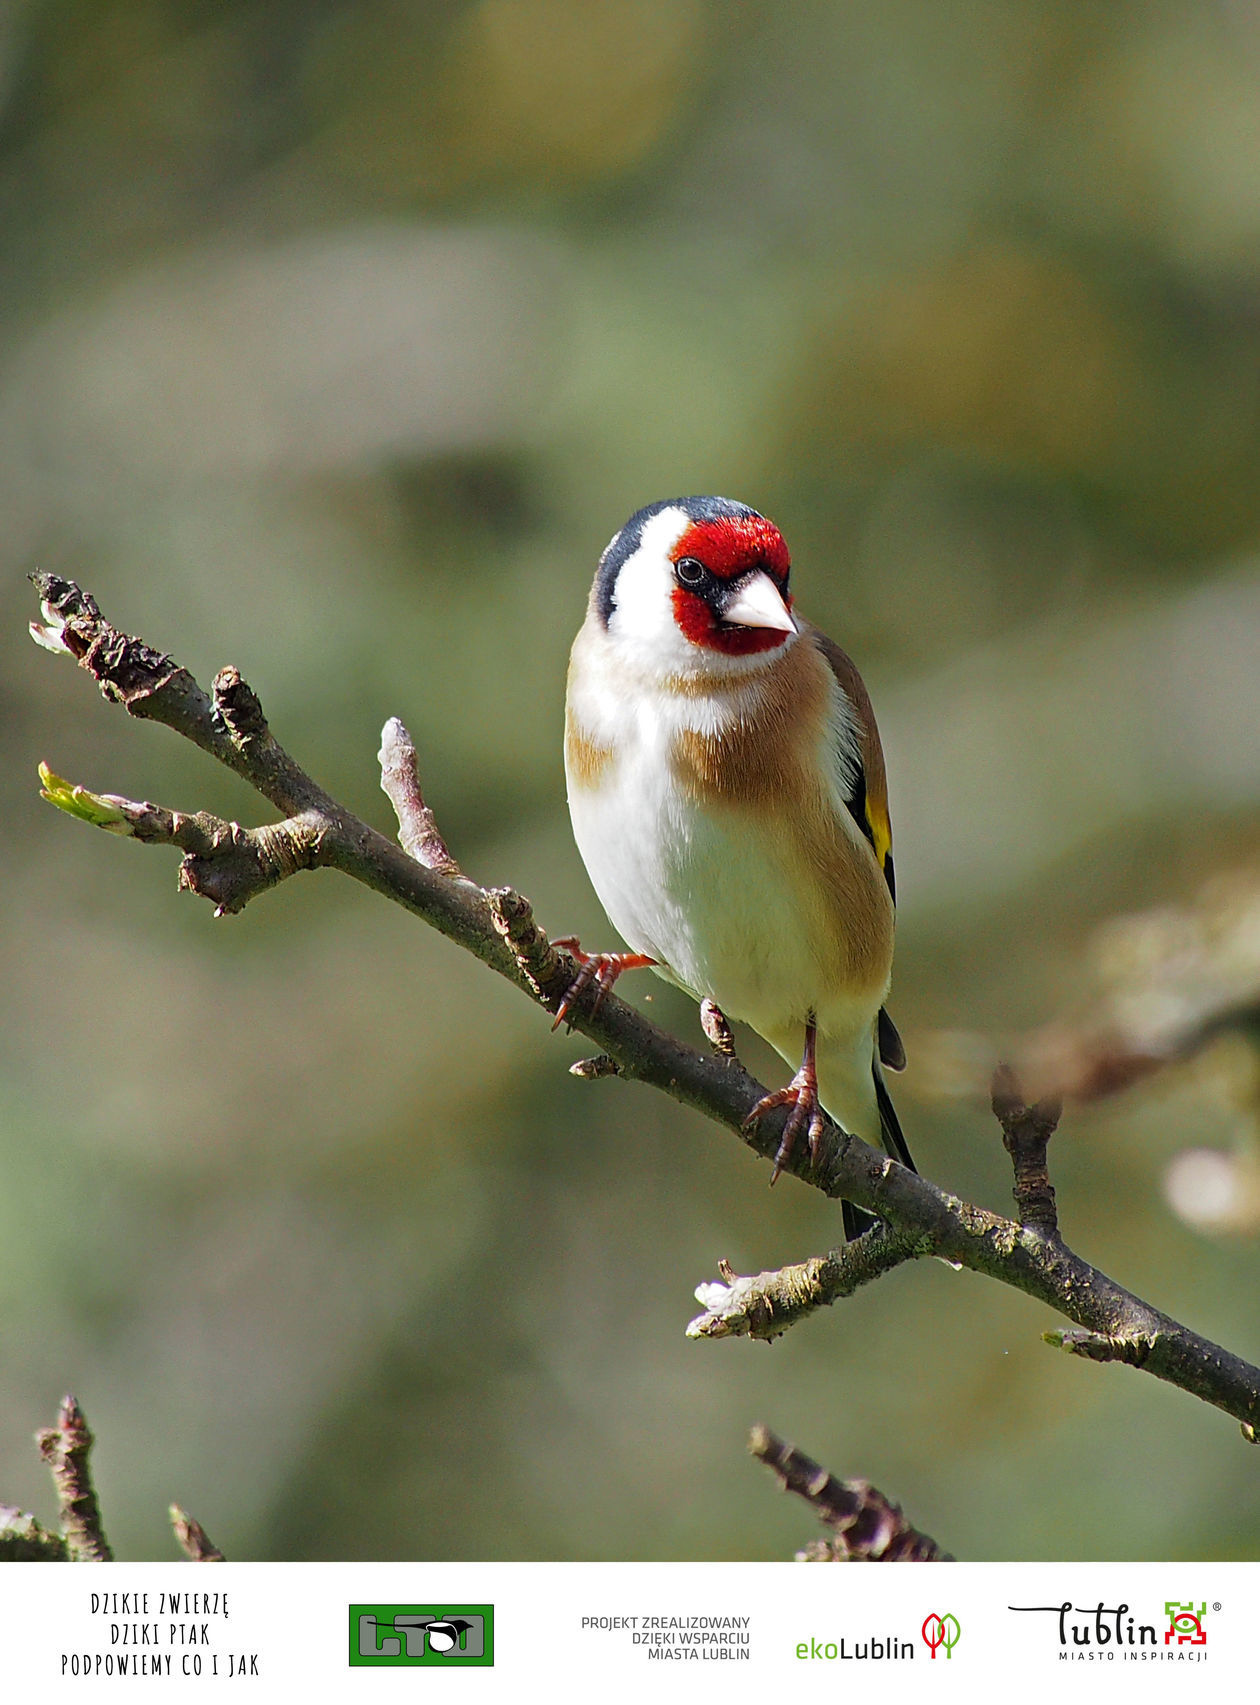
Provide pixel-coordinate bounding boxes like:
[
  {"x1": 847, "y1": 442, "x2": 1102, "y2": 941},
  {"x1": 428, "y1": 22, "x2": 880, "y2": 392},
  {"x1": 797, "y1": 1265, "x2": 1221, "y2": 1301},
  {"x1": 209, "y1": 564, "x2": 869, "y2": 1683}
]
[{"x1": 24, "y1": 575, "x2": 1260, "y2": 1427}]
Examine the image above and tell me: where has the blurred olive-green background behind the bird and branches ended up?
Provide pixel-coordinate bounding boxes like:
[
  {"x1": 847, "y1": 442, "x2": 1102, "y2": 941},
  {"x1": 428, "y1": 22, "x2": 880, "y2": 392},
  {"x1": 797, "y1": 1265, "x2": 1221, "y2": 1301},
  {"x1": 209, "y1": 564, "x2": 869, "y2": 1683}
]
[{"x1": 0, "y1": 0, "x2": 1260, "y2": 1558}]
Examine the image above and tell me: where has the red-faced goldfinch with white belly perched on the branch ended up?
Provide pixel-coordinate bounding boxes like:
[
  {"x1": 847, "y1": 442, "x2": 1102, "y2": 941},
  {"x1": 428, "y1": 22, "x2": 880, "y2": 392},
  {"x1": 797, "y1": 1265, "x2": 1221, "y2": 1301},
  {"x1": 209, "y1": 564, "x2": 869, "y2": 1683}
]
[{"x1": 556, "y1": 496, "x2": 914, "y2": 1236}]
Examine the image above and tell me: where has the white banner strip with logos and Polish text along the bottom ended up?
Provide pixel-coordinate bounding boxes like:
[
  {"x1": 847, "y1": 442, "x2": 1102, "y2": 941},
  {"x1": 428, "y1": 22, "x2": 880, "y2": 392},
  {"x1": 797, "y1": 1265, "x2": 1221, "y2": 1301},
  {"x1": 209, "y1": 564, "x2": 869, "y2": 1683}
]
[{"x1": 0, "y1": 1562, "x2": 1241, "y2": 1705}]
